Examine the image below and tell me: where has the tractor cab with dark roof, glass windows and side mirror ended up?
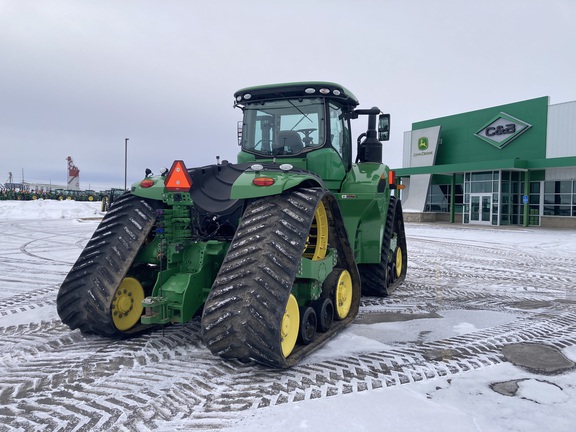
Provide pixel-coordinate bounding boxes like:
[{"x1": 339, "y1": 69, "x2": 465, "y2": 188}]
[{"x1": 234, "y1": 82, "x2": 389, "y2": 189}]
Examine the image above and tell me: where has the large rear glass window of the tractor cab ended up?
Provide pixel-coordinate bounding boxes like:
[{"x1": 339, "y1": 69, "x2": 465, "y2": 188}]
[{"x1": 242, "y1": 98, "x2": 324, "y2": 156}]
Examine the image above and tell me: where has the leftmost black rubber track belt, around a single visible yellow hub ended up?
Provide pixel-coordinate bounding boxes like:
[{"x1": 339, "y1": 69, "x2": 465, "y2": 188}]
[{"x1": 56, "y1": 193, "x2": 161, "y2": 337}]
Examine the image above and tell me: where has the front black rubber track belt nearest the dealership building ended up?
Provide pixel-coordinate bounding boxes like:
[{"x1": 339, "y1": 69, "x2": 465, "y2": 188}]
[{"x1": 358, "y1": 196, "x2": 408, "y2": 297}]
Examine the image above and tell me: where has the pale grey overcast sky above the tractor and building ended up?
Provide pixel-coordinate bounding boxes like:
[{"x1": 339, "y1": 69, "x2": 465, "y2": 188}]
[{"x1": 0, "y1": 0, "x2": 576, "y2": 189}]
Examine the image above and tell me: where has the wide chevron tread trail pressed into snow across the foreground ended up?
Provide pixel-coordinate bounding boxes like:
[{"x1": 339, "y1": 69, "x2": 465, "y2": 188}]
[{"x1": 0, "y1": 312, "x2": 576, "y2": 430}]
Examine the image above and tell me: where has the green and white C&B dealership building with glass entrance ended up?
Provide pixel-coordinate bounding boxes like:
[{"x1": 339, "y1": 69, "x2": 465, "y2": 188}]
[{"x1": 396, "y1": 97, "x2": 576, "y2": 228}]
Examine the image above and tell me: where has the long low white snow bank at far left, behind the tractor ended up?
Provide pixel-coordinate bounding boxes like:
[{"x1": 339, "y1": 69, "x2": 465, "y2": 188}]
[{"x1": 0, "y1": 199, "x2": 103, "y2": 220}]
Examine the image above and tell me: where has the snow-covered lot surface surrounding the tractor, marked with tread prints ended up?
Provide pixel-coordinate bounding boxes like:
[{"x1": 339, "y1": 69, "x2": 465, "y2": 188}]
[{"x1": 0, "y1": 201, "x2": 576, "y2": 432}]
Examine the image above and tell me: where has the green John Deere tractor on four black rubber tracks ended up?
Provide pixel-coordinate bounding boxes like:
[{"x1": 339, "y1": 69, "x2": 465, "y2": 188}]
[{"x1": 57, "y1": 82, "x2": 407, "y2": 368}]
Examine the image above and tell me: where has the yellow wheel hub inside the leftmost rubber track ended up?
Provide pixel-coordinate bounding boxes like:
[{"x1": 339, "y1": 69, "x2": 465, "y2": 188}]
[{"x1": 111, "y1": 277, "x2": 144, "y2": 331}]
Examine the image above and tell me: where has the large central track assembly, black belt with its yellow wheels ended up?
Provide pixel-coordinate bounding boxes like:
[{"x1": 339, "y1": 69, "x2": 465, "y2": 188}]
[{"x1": 202, "y1": 189, "x2": 360, "y2": 368}]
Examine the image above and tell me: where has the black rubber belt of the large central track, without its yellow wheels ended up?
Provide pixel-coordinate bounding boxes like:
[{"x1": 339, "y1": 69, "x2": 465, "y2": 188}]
[{"x1": 202, "y1": 189, "x2": 360, "y2": 368}]
